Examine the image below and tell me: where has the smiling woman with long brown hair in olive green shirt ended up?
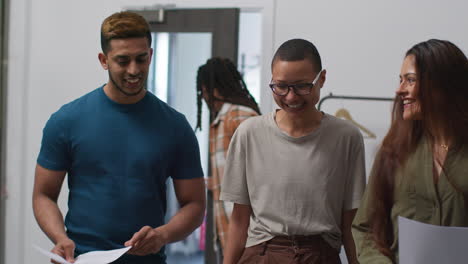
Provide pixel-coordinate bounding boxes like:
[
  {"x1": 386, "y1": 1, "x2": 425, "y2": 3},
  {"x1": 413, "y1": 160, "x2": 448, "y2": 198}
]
[{"x1": 353, "y1": 39, "x2": 468, "y2": 263}]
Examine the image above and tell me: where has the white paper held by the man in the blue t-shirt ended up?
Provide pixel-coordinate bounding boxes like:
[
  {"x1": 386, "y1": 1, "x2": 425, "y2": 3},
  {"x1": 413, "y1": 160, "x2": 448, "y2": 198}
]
[{"x1": 33, "y1": 245, "x2": 131, "y2": 264}]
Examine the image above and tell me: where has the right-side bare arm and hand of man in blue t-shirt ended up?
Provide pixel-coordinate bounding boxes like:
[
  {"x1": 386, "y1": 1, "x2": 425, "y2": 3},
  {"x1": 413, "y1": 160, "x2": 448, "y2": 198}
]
[{"x1": 125, "y1": 178, "x2": 205, "y2": 256}]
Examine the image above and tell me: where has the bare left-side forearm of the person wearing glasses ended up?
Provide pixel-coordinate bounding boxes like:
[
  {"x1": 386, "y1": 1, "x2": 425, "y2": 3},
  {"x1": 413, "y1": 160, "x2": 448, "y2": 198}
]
[{"x1": 223, "y1": 203, "x2": 252, "y2": 264}]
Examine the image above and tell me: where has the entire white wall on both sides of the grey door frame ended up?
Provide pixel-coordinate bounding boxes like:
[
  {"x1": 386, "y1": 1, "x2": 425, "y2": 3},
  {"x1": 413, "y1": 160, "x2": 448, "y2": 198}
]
[{"x1": 5, "y1": 0, "x2": 468, "y2": 264}]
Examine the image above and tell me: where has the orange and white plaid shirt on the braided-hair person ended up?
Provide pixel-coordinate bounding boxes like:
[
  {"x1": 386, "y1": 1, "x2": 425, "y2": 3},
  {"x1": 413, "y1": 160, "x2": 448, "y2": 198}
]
[{"x1": 207, "y1": 102, "x2": 258, "y2": 251}]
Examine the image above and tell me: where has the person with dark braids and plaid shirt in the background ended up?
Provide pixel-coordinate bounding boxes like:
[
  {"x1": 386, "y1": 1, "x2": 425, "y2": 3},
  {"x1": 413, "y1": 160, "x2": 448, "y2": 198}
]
[{"x1": 196, "y1": 57, "x2": 260, "y2": 256}]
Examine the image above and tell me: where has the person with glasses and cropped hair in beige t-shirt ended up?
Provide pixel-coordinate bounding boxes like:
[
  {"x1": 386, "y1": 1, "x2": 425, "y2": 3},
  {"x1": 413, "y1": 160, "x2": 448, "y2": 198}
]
[{"x1": 221, "y1": 39, "x2": 365, "y2": 264}]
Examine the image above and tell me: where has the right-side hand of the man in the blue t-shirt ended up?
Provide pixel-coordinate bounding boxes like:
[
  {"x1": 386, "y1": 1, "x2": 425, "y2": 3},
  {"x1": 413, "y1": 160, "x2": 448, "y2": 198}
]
[{"x1": 125, "y1": 226, "x2": 167, "y2": 256}]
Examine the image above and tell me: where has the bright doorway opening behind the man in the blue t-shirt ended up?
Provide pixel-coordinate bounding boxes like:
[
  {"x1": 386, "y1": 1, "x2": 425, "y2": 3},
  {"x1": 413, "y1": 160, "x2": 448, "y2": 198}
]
[{"x1": 147, "y1": 32, "x2": 211, "y2": 264}]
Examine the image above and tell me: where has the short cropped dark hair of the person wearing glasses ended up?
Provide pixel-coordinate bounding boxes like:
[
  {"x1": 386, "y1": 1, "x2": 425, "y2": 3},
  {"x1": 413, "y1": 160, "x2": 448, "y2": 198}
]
[{"x1": 271, "y1": 39, "x2": 322, "y2": 71}]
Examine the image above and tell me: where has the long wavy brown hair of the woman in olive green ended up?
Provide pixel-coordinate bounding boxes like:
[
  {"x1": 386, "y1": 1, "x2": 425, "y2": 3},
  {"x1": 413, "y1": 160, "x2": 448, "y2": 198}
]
[{"x1": 367, "y1": 39, "x2": 468, "y2": 259}]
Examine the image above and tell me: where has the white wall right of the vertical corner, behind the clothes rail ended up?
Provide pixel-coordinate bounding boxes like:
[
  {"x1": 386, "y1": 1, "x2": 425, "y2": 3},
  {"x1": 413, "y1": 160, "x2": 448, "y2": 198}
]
[{"x1": 274, "y1": 0, "x2": 468, "y2": 177}]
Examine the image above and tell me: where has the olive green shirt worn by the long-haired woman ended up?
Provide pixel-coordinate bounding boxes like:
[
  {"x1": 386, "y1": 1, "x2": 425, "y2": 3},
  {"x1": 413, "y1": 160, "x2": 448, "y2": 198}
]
[{"x1": 352, "y1": 140, "x2": 468, "y2": 264}]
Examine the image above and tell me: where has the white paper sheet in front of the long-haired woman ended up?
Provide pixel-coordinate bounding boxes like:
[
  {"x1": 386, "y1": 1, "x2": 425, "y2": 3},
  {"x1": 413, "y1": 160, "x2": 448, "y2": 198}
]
[{"x1": 398, "y1": 216, "x2": 468, "y2": 264}]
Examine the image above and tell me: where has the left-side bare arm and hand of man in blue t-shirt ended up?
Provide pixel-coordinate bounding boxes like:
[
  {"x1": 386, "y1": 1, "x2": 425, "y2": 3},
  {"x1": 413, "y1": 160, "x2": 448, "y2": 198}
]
[{"x1": 33, "y1": 164, "x2": 75, "y2": 262}]
